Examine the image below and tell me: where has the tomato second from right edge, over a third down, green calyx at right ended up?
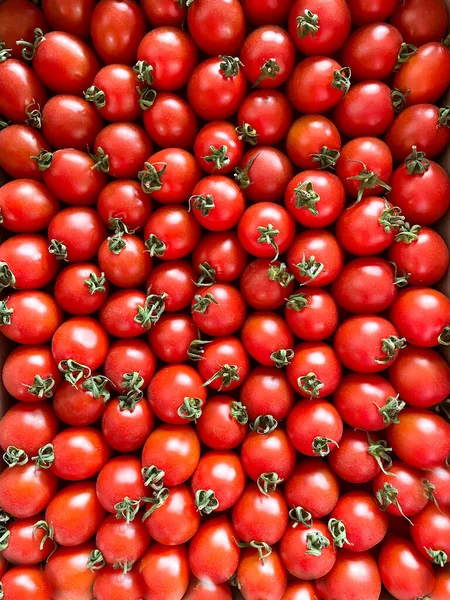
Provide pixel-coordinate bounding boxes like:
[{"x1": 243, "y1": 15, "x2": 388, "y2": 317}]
[{"x1": 336, "y1": 196, "x2": 399, "y2": 256}]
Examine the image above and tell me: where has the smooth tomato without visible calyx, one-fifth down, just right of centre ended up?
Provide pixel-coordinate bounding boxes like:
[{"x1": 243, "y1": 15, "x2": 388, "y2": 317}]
[{"x1": 237, "y1": 90, "x2": 292, "y2": 146}]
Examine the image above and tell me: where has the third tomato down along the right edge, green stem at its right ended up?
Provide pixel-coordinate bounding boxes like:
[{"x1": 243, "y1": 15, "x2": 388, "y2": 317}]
[{"x1": 385, "y1": 104, "x2": 450, "y2": 163}]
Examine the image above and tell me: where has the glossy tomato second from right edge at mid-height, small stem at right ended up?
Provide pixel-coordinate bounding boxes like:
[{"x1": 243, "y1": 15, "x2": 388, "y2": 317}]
[{"x1": 332, "y1": 257, "x2": 398, "y2": 314}]
